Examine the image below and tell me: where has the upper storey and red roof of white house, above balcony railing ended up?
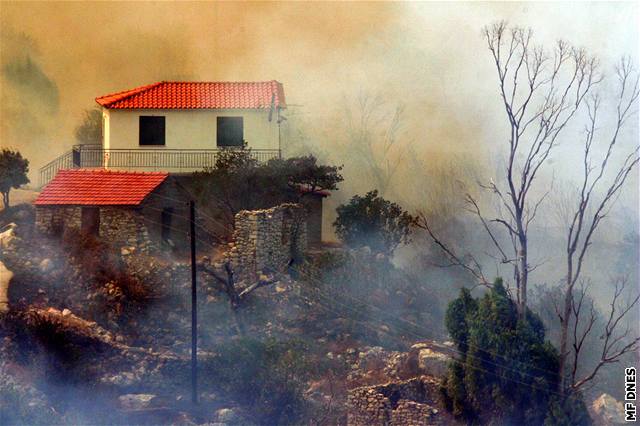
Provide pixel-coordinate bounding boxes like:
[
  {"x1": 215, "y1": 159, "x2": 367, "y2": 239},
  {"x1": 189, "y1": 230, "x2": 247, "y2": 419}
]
[{"x1": 96, "y1": 80, "x2": 285, "y2": 154}]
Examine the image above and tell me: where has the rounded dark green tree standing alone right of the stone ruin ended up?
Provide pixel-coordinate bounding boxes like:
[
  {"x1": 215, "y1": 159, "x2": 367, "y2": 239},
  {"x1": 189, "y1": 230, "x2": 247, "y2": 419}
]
[{"x1": 333, "y1": 190, "x2": 415, "y2": 254}]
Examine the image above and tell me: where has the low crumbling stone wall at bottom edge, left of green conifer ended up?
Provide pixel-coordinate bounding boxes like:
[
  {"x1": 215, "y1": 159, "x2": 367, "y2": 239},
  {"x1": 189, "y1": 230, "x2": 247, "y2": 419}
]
[{"x1": 347, "y1": 376, "x2": 442, "y2": 426}]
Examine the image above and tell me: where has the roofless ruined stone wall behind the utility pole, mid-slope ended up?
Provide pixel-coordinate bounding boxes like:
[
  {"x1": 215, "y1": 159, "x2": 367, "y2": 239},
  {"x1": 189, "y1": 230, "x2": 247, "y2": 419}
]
[{"x1": 225, "y1": 203, "x2": 307, "y2": 281}]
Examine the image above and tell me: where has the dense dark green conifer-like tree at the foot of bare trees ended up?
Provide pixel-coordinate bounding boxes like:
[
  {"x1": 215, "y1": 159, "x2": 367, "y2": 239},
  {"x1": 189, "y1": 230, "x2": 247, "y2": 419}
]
[{"x1": 442, "y1": 279, "x2": 588, "y2": 425}]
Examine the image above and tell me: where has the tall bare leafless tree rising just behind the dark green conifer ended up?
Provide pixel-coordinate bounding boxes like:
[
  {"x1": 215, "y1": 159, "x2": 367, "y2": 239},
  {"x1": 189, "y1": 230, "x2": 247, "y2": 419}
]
[{"x1": 423, "y1": 22, "x2": 601, "y2": 316}]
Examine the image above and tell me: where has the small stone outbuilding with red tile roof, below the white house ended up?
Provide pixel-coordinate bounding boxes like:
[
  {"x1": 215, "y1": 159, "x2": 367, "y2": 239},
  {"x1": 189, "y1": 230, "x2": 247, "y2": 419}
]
[{"x1": 34, "y1": 169, "x2": 189, "y2": 252}]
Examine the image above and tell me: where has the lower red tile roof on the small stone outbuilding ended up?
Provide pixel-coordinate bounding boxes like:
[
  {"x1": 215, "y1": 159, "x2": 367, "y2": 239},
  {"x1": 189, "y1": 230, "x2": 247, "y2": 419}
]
[{"x1": 35, "y1": 169, "x2": 169, "y2": 206}]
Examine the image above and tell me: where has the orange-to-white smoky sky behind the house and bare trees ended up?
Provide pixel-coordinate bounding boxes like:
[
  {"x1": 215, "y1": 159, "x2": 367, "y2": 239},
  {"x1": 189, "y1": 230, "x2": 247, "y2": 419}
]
[{"x1": 0, "y1": 2, "x2": 638, "y2": 216}]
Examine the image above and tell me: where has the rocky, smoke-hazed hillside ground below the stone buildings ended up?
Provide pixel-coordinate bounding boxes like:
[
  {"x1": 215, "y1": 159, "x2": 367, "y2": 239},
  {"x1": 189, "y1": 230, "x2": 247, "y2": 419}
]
[{"x1": 0, "y1": 207, "x2": 619, "y2": 425}]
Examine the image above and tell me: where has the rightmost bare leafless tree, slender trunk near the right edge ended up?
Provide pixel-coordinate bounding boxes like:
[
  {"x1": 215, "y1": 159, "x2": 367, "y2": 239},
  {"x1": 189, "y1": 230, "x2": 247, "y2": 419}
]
[{"x1": 559, "y1": 58, "x2": 640, "y2": 391}]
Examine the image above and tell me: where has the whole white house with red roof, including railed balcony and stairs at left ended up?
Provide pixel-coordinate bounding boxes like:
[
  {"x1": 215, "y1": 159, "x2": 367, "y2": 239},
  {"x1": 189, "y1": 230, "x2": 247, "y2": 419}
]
[{"x1": 40, "y1": 80, "x2": 286, "y2": 185}]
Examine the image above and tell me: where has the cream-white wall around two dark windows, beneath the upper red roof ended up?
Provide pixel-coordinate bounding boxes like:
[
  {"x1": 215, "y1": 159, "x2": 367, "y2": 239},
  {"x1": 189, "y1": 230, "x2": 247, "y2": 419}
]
[{"x1": 103, "y1": 109, "x2": 278, "y2": 150}]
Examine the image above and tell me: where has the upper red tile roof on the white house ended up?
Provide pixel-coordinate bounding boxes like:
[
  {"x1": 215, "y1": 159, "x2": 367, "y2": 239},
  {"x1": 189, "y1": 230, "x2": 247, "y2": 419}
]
[{"x1": 96, "y1": 80, "x2": 286, "y2": 109}]
